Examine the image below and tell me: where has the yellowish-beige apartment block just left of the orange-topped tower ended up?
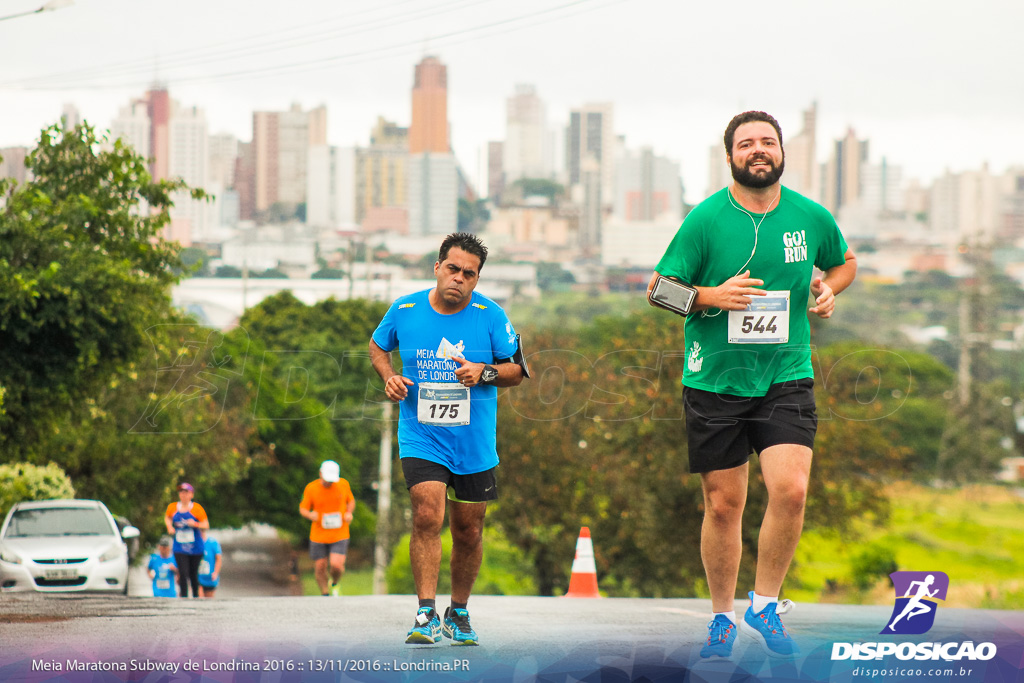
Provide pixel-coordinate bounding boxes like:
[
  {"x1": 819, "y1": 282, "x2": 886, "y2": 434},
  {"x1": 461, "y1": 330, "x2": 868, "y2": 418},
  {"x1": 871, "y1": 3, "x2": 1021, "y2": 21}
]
[{"x1": 354, "y1": 117, "x2": 409, "y2": 232}]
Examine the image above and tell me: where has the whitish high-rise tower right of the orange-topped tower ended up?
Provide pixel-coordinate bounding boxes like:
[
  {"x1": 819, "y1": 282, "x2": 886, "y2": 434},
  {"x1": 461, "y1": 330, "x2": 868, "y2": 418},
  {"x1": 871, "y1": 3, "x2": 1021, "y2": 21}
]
[{"x1": 502, "y1": 85, "x2": 554, "y2": 183}]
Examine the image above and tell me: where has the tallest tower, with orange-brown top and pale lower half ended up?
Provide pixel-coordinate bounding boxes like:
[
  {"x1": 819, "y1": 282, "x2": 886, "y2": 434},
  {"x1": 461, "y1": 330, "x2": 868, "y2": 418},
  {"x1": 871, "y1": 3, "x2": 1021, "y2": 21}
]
[{"x1": 409, "y1": 56, "x2": 459, "y2": 234}]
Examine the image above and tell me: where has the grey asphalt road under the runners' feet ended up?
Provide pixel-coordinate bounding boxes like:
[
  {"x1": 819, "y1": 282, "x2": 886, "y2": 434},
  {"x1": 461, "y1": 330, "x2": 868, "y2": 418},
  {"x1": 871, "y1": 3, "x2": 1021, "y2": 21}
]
[{"x1": 0, "y1": 532, "x2": 1024, "y2": 683}]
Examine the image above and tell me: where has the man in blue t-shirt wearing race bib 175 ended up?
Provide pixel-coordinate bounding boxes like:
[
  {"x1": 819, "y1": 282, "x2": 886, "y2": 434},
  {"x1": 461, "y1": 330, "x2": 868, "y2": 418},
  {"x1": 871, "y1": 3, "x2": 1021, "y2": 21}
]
[{"x1": 370, "y1": 232, "x2": 529, "y2": 645}]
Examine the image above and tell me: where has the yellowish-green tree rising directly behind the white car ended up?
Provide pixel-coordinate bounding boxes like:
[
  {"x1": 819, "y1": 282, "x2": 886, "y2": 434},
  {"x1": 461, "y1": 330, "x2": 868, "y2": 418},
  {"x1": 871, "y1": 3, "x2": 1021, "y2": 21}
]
[{"x1": 49, "y1": 316, "x2": 269, "y2": 541}]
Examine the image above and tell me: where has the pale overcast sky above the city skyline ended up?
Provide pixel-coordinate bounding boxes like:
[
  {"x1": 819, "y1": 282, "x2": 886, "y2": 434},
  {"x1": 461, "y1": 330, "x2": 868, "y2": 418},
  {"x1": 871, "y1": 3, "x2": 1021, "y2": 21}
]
[{"x1": 0, "y1": 0, "x2": 1024, "y2": 202}]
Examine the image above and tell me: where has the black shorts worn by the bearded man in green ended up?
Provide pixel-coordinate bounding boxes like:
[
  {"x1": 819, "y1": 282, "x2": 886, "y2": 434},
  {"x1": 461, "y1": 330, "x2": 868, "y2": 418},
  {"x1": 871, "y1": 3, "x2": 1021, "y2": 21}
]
[{"x1": 683, "y1": 378, "x2": 818, "y2": 474}]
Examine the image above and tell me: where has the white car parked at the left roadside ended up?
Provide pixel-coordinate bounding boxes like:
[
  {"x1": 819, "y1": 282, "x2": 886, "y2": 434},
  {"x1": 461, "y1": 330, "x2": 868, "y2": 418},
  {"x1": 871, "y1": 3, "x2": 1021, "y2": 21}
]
[{"x1": 0, "y1": 500, "x2": 139, "y2": 595}]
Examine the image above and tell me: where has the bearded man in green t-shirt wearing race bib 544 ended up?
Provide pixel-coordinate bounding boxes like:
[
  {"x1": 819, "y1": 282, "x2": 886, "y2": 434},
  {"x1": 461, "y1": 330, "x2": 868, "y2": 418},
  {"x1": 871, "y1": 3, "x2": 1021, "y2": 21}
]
[{"x1": 648, "y1": 112, "x2": 857, "y2": 658}]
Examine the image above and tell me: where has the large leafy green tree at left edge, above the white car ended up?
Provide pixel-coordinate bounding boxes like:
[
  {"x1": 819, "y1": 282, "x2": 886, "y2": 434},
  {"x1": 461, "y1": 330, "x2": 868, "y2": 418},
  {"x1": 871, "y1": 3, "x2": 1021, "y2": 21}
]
[{"x1": 0, "y1": 124, "x2": 197, "y2": 461}]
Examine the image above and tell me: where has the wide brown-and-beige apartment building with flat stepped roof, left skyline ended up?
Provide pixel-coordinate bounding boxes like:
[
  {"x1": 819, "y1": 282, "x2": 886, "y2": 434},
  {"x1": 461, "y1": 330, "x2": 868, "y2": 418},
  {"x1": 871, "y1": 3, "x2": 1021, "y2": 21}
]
[{"x1": 252, "y1": 103, "x2": 327, "y2": 212}]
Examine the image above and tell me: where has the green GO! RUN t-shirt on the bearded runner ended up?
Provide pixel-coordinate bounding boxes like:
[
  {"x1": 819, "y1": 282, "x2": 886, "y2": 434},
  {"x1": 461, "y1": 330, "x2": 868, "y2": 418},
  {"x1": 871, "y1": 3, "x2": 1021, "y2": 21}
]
[{"x1": 657, "y1": 187, "x2": 847, "y2": 396}]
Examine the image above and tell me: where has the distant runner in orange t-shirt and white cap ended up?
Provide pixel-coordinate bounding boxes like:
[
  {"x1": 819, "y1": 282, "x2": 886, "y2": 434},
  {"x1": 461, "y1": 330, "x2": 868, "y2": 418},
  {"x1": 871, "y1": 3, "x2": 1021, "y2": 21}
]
[{"x1": 299, "y1": 460, "x2": 355, "y2": 596}]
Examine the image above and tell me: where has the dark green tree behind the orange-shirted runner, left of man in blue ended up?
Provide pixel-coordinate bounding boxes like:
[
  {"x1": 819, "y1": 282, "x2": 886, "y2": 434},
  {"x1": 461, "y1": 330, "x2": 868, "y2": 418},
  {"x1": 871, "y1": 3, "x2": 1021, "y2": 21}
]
[{"x1": 209, "y1": 291, "x2": 393, "y2": 550}]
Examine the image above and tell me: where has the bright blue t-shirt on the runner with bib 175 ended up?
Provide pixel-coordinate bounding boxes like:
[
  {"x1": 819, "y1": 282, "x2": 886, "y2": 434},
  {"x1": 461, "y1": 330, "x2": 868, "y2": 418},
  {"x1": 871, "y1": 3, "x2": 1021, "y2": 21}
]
[{"x1": 373, "y1": 290, "x2": 516, "y2": 474}]
